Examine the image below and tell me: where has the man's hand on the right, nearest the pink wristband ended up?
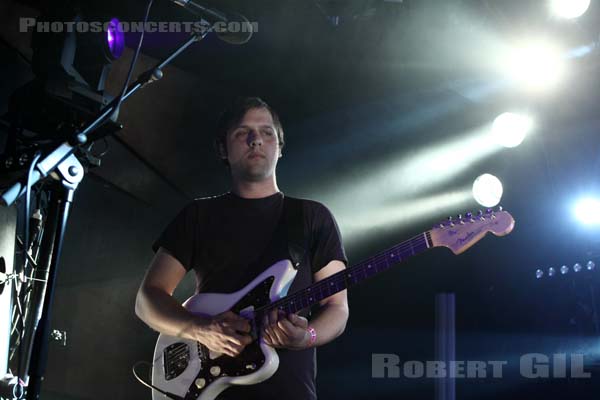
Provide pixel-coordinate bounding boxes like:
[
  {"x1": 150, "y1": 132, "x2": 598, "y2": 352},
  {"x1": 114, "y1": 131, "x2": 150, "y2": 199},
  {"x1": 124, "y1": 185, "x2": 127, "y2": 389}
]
[{"x1": 262, "y1": 310, "x2": 310, "y2": 350}]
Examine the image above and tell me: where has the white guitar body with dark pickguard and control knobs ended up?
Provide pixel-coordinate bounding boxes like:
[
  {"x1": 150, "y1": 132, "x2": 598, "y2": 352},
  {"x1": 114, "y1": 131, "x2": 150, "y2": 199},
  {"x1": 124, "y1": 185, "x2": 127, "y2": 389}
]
[{"x1": 152, "y1": 260, "x2": 296, "y2": 400}]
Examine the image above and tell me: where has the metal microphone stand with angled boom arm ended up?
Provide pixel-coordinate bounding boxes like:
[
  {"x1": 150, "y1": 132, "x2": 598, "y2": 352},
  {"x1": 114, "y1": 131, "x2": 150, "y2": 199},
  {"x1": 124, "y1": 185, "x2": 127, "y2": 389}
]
[{"x1": 0, "y1": 29, "x2": 210, "y2": 400}]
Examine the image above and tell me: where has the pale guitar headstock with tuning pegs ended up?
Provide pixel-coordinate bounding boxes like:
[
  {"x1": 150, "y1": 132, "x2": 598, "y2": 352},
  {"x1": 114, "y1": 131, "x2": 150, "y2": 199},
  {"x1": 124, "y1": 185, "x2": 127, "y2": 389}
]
[{"x1": 430, "y1": 207, "x2": 515, "y2": 254}]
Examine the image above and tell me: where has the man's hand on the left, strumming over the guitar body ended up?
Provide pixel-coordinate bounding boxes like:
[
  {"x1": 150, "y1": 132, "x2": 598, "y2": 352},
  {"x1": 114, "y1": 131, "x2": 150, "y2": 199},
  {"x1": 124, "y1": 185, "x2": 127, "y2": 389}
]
[{"x1": 195, "y1": 311, "x2": 253, "y2": 357}]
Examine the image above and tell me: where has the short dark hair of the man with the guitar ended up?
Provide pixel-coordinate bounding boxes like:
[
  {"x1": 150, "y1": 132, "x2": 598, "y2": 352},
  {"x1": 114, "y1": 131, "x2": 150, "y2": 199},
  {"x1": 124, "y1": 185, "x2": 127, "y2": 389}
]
[{"x1": 214, "y1": 97, "x2": 285, "y2": 165}]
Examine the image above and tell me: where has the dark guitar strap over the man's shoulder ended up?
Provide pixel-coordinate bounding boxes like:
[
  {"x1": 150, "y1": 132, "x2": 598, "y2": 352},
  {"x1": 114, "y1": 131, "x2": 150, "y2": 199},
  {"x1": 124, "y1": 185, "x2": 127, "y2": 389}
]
[{"x1": 283, "y1": 196, "x2": 309, "y2": 269}]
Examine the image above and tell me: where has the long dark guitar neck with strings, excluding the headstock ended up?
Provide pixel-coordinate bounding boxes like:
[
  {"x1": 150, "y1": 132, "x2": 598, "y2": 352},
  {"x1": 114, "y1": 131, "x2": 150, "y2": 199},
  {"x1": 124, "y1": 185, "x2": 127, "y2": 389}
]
[{"x1": 257, "y1": 231, "x2": 433, "y2": 314}]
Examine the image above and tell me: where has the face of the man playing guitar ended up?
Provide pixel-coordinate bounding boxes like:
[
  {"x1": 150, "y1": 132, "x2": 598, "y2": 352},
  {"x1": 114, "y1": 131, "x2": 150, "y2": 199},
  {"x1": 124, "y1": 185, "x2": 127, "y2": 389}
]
[{"x1": 227, "y1": 108, "x2": 281, "y2": 182}]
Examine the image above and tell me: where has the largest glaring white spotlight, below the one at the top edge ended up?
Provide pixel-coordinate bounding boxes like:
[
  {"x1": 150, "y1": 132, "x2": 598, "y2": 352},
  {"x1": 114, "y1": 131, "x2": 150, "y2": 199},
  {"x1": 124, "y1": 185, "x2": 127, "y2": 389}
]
[{"x1": 504, "y1": 41, "x2": 564, "y2": 91}]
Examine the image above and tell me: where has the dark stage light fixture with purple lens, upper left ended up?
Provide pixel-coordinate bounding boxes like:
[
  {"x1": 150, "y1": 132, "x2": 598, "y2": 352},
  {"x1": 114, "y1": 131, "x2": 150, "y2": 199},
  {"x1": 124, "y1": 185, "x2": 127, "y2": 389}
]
[{"x1": 2, "y1": 11, "x2": 125, "y2": 147}]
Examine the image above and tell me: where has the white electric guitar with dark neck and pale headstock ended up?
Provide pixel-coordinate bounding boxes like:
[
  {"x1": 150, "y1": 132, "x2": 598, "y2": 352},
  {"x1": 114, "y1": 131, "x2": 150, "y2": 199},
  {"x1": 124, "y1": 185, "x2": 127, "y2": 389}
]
[{"x1": 152, "y1": 208, "x2": 515, "y2": 400}]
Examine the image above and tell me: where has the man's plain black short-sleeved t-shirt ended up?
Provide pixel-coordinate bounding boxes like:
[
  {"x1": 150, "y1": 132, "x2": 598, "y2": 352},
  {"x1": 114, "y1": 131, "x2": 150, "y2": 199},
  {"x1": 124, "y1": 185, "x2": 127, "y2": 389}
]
[{"x1": 152, "y1": 192, "x2": 347, "y2": 400}]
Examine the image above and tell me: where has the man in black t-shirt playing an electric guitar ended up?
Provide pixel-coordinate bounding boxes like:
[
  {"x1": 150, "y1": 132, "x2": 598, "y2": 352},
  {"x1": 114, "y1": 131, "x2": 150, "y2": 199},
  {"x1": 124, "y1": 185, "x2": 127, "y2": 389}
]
[{"x1": 135, "y1": 98, "x2": 348, "y2": 400}]
